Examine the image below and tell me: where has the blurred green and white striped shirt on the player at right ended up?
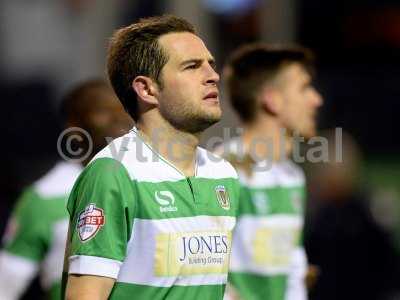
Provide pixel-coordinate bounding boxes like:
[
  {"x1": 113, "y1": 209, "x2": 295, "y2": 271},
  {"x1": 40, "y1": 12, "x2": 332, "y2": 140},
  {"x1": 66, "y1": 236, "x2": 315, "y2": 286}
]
[{"x1": 226, "y1": 140, "x2": 307, "y2": 300}]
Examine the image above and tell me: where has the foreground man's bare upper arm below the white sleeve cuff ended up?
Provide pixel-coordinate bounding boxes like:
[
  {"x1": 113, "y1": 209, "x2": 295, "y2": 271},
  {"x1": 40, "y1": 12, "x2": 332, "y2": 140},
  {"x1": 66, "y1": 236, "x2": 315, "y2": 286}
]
[{"x1": 65, "y1": 275, "x2": 115, "y2": 300}]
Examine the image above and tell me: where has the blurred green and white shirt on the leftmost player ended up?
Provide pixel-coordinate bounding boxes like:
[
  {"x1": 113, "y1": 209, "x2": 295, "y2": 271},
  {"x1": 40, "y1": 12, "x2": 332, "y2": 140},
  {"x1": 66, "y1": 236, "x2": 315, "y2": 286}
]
[{"x1": 0, "y1": 162, "x2": 82, "y2": 299}]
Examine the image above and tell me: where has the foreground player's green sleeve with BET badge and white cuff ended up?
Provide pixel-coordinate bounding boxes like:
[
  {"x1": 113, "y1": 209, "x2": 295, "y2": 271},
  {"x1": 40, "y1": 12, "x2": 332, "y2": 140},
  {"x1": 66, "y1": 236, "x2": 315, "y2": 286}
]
[{"x1": 67, "y1": 158, "x2": 135, "y2": 279}]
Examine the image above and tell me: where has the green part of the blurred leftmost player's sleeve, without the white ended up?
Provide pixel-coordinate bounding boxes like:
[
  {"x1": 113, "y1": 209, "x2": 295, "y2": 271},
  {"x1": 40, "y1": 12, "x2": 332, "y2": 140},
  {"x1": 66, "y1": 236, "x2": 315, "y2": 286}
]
[{"x1": 4, "y1": 188, "x2": 51, "y2": 262}]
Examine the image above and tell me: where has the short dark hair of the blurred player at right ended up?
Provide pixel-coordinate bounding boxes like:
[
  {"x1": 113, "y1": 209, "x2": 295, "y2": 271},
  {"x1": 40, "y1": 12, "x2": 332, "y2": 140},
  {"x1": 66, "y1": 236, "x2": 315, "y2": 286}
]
[{"x1": 225, "y1": 43, "x2": 314, "y2": 123}]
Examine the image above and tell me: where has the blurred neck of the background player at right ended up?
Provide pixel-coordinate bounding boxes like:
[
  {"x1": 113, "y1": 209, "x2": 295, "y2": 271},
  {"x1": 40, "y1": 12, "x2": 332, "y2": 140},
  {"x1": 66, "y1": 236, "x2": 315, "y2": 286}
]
[{"x1": 242, "y1": 116, "x2": 293, "y2": 161}]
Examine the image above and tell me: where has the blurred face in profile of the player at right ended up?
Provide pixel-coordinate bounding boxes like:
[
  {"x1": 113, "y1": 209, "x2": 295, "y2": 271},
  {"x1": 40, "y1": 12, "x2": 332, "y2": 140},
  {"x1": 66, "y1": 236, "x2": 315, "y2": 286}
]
[{"x1": 278, "y1": 63, "x2": 322, "y2": 138}]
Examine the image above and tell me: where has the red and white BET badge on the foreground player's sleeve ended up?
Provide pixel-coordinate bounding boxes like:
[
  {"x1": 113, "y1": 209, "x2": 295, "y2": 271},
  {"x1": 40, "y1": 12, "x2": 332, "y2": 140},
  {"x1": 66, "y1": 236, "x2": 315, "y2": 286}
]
[{"x1": 77, "y1": 203, "x2": 105, "y2": 242}]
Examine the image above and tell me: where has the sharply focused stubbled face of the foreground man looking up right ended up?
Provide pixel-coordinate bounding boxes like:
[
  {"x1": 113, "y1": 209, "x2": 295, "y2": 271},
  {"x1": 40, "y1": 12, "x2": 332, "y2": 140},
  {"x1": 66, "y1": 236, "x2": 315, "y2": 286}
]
[{"x1": 158, "y1": 32, "x2": 221, "y2": 133}]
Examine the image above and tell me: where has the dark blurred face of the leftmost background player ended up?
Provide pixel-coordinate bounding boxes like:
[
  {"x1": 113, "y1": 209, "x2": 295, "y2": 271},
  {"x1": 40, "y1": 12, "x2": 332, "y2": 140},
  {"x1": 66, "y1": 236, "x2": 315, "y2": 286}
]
[{"x1": 81, "y1": 87, "x2": 133, "y2": 149}]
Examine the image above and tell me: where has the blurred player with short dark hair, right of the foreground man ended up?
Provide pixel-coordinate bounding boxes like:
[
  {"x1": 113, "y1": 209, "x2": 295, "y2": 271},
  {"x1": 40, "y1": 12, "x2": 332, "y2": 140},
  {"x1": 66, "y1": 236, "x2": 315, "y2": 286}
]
[{"x1": 222, "y1": 44, "x2": 322, "y2": 300}]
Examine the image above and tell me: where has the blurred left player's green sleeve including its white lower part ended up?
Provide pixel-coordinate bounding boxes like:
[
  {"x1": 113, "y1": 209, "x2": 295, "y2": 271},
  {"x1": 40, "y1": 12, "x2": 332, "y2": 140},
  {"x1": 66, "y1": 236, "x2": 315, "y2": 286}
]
[{"x1": 0, "y1": 189, "x2": 46, "y2": 299}]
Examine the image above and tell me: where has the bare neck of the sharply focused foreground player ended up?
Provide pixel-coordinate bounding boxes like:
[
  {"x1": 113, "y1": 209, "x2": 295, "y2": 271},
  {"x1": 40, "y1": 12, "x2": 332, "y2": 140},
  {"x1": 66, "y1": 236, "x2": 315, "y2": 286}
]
[{"x1": 137, "y1": 113, "x2": 200, "y2": 177}]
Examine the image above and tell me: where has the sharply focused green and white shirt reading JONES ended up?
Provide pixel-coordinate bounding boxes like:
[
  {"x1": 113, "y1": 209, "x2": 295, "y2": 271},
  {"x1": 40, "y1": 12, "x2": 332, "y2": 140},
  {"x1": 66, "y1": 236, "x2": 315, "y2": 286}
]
[{"x1": 63, "y1": 129, "x2": 240, "y2": 300}]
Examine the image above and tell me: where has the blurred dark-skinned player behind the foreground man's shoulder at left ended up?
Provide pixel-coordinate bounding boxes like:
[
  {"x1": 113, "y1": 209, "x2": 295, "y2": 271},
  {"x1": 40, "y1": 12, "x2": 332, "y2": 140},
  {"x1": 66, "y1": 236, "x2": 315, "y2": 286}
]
[{"x1": 0, "y1": 80, "x2": 133, "y2": 300}]
